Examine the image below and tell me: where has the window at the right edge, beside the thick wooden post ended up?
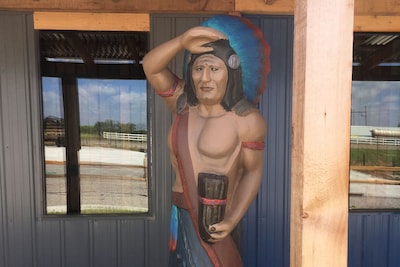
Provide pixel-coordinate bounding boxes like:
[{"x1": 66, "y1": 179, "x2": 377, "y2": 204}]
[{"x1": 349, "y1": 33, "x2": 400, "y2": 210}]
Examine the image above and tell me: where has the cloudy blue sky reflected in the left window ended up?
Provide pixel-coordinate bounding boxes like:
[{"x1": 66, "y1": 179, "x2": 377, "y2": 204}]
[{"x1": 42, "y1": 77, "x2": 147, "y2": 125}]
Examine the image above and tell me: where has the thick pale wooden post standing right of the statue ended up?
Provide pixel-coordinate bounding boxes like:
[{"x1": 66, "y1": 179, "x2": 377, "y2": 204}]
[{"x1": 290, "y1": 0, "x2": 354, "y2": 267}]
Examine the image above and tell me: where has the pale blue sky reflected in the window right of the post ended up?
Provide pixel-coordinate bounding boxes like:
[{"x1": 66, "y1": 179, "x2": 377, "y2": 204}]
[{"x1": 351, "y1": 81, "x2": 400, "y2": 127}]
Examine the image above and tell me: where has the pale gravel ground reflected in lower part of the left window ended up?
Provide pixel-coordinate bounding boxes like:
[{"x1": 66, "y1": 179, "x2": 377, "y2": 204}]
[{"x1": 45, "y1": 146, "x2": 148, "y2": 213}]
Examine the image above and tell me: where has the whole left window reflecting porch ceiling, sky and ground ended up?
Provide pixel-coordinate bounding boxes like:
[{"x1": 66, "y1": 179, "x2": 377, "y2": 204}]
[{"x1": 39, "y1": 31, "x2": 149, "y2": 214}]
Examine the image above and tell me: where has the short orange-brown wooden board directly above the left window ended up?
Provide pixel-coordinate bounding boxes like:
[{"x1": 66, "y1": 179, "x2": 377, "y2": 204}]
[{"x1": 33, "y1": 12, "x2": 150, "y2": 31}]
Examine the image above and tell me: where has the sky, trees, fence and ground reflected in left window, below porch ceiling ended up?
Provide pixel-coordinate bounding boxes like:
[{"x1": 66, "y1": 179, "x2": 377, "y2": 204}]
[{"x1": 43, "y1": 77, "x2": 148, "y2": 214}]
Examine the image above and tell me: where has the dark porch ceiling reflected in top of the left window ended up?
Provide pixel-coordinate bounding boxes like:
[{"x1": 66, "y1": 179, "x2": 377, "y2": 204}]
[{"x1": 39, "y1": 30, "x2": 149, "y2": 79}]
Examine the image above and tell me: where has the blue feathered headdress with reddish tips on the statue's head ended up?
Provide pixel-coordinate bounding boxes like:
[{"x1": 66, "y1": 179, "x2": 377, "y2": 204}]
[{"x1": 202, "y1": 15, "x2": 270, "y2": 104}]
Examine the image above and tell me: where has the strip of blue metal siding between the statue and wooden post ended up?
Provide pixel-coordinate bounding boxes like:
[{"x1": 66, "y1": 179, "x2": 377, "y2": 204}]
[{"x1": 260, "y1": 17, "x2": 293, "y2": 266}]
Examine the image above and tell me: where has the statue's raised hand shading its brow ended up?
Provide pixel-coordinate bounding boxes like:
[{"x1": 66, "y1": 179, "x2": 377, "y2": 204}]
[{"x1": 181, "y1": 26, "x2": 227, "y2": 54}]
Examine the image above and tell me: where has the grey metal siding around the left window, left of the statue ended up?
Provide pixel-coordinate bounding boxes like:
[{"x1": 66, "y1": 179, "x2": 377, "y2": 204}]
[{"x1": 0, "y1": 12, "x2": 172, "y2": 267}]
